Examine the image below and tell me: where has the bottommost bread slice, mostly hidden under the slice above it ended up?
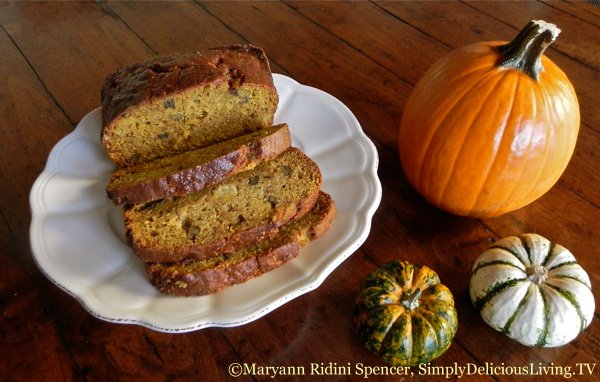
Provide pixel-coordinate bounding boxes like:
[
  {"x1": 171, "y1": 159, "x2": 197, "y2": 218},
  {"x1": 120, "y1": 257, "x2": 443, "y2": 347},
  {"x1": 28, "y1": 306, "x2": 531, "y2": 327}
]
[{"x1": 146, "y1": 192, "x2": 336, "y2": 296}]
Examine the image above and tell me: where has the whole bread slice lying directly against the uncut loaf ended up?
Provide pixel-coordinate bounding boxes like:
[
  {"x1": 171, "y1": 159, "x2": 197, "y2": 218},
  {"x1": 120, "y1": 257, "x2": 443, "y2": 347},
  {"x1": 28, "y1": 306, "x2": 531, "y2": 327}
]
[{"x1": 106, "y1": 124, "x2": 291, "y2": 205}]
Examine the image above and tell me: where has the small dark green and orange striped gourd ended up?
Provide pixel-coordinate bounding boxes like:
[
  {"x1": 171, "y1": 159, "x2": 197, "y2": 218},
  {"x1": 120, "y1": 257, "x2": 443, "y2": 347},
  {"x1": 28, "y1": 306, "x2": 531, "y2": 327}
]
[{"x1": 354, "y1": 261, "x2": 458, "y2": 366}]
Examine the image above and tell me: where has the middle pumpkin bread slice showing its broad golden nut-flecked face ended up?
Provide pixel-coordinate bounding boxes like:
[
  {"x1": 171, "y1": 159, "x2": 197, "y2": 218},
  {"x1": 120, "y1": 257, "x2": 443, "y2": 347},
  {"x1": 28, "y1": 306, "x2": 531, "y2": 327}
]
[{"x1": 124, "y1": 147, "x2": 322, "y2": 262}]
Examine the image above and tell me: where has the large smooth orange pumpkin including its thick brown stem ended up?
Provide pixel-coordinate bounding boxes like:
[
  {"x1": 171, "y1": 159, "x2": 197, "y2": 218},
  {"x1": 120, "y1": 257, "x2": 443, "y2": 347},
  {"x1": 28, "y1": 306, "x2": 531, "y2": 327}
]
[{"x1": 398, "y1": 21, "x2": 579, "y2": 217}]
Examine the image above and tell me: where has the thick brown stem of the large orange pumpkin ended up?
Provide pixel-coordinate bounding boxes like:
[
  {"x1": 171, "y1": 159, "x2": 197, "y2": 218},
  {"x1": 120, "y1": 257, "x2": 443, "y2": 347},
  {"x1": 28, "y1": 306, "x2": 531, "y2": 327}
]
[{"x1": 497, "y1": 20, "x2": 560, "y2": 80}]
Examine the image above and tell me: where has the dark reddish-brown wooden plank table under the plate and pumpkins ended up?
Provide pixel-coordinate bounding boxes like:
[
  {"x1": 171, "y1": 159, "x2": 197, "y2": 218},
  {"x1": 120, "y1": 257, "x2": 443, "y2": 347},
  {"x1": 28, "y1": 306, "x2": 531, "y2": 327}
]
[{"x1": 0, "y1": 1, "x2": 600, "y2": 381}]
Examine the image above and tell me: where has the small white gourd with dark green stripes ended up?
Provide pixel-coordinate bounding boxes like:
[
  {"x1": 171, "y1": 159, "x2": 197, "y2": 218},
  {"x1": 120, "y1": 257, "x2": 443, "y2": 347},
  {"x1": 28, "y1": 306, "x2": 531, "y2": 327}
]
[{"x1": 469, "y1": 234, "x2": 596, "y2": 347}]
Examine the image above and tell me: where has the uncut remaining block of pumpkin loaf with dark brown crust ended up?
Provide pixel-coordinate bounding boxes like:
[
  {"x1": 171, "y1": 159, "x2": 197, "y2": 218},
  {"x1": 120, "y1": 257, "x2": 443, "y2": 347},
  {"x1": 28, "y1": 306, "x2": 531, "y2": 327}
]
[{"x1": 101, "y1": 45, "x2": 278, "y2": 167}]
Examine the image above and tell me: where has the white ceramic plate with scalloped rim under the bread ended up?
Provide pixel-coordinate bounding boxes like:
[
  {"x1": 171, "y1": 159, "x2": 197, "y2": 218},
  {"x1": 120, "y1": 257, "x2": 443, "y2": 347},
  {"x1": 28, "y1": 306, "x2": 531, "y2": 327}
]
[{"x1": 30, "y1": 74, "x2": 381, "y2": 332}]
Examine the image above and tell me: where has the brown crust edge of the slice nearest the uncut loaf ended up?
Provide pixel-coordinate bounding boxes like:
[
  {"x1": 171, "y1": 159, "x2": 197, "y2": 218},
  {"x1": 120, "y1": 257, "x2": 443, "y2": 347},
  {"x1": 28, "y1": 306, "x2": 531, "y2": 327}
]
[{"x1": 106, "y1": 124, "x2": 292, "y2": 205}]
